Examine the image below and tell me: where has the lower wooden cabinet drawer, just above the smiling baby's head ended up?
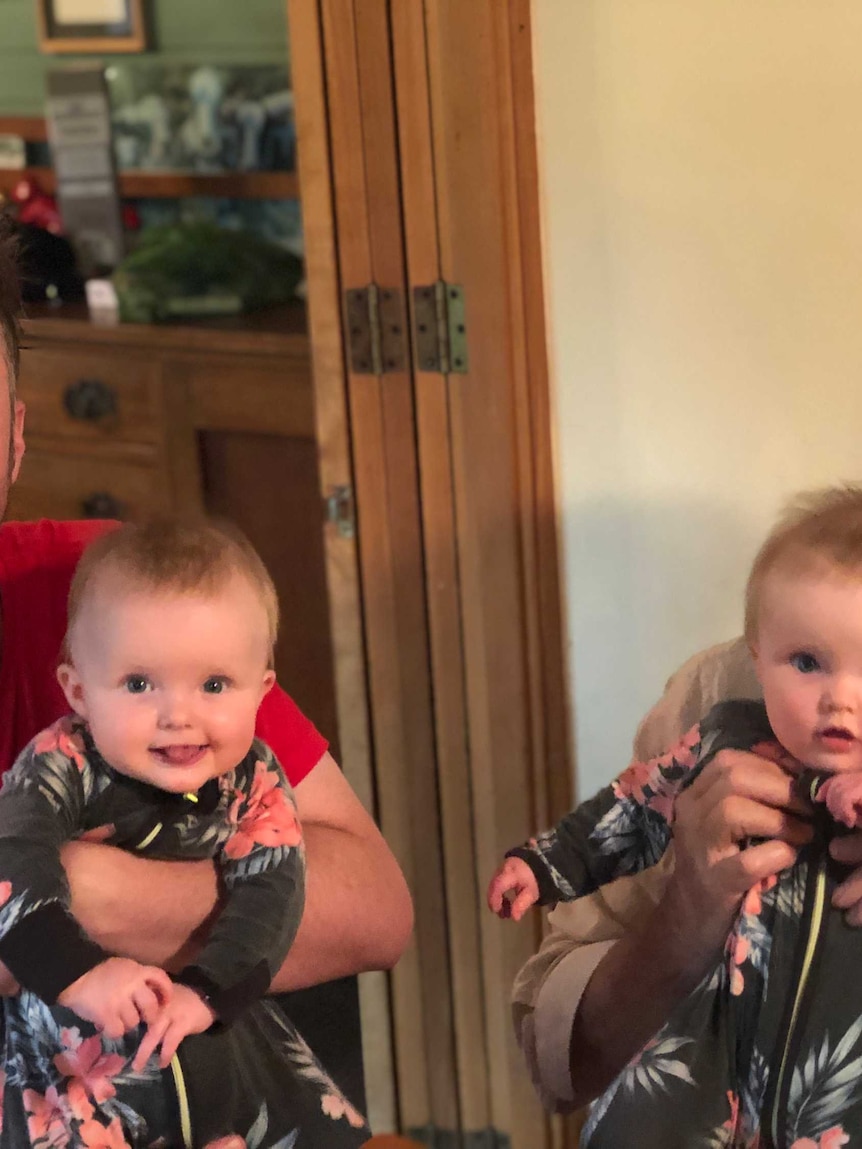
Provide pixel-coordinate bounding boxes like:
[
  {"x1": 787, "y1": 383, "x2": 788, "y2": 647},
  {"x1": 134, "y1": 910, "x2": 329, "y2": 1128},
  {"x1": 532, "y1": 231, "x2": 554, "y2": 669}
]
[{"x1": 8, "y1": 448, "x2": 170, "y2": 519}]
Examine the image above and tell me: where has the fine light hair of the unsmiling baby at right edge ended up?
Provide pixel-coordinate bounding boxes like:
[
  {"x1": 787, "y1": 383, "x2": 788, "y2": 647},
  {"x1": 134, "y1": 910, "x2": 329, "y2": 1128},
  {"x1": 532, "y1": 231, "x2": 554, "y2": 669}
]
[{"x1": 745, "y1": 483, "x2": 862, "y2": 645}]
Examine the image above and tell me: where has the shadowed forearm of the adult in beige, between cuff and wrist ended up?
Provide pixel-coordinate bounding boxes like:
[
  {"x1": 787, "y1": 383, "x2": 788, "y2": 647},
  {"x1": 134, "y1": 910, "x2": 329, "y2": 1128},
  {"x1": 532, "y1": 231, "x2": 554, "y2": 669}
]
[{"x1": 569, "y1": 895, "x2": 730, "y2": 1106}]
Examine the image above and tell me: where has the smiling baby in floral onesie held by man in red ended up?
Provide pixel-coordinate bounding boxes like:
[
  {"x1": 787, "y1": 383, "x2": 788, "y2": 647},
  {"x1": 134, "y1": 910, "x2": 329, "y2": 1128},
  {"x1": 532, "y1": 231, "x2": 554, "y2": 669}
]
[{"x1": 0, "y1": 519, "x2": 305, "y2": 1143}]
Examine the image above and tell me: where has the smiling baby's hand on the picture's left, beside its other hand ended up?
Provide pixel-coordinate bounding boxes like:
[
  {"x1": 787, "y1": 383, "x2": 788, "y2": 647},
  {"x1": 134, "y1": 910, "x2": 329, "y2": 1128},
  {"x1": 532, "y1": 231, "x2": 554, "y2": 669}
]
[{"x1": 57, "y1": 957, "x2": 174, "y2": 1038}]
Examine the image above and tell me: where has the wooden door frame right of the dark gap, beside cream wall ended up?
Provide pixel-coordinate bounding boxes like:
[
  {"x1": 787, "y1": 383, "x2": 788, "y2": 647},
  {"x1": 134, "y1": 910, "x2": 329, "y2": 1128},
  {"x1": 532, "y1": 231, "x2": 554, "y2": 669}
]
[{"x1": 392, "y1": 0, "x2": 570, "y2": 1149}]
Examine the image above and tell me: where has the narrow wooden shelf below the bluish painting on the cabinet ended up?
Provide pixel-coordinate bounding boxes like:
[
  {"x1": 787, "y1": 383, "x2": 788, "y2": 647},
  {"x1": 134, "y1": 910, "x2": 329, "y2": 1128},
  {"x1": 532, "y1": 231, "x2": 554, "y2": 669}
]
[{"x1": 0, "y1": 168, "x2": 299, "y2": 200}]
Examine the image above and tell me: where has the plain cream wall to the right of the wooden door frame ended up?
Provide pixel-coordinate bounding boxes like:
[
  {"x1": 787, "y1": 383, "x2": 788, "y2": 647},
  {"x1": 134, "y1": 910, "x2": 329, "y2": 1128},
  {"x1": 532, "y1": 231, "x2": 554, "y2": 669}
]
[{"x1": 533, "y1": 0, "x2": 862, "y2": 795}]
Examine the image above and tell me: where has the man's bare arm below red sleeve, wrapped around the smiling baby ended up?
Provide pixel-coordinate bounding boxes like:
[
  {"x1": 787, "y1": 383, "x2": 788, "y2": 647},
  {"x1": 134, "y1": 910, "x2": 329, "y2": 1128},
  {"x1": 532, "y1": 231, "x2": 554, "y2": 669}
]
[{"x1": 63, "y1": 753, "x2": 413, "y2": 992}]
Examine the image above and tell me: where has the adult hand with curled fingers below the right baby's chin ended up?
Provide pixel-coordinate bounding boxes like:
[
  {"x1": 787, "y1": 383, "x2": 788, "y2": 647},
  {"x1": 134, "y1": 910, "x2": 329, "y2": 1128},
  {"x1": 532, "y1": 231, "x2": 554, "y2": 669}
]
[{"x1": 665, "y1": 750, "x2": 818, "y2": 944}]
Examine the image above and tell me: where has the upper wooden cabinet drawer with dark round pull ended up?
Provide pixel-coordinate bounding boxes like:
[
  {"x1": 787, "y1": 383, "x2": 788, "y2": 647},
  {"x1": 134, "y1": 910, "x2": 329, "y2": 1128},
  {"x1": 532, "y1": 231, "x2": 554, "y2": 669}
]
[{"x1": 18, "y1": 347, "x2": 161, "y2": 442}]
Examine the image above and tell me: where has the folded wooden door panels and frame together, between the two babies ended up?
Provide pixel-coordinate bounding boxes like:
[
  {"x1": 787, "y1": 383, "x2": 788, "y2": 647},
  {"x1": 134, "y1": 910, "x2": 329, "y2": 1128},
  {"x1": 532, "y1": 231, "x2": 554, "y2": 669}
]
[{"x1": 288, "y1": 0, "x2": 570, "y2": 1149}]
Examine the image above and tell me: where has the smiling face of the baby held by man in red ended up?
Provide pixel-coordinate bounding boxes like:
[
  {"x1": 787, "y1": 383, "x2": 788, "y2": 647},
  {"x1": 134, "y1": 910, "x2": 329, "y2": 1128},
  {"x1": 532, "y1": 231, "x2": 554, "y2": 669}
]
[{"x1": 59, "y1": 576, "x2": 275, "y2": 794}]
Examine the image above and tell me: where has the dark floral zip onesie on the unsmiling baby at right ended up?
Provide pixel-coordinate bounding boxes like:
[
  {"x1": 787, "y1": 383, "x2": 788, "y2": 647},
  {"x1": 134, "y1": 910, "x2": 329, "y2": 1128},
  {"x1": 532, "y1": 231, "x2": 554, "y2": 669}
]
[{"x1": 510, "y1": 701, "x2": 862, "y2": 1149}]
